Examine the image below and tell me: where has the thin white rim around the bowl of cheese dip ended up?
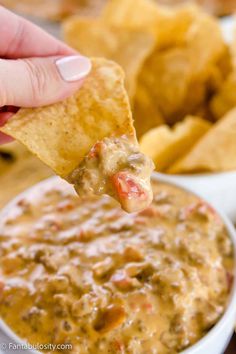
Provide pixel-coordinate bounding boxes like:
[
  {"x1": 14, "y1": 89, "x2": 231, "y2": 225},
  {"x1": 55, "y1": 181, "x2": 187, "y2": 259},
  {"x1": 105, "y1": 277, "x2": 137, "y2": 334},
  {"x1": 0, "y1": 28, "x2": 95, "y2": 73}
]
[{"x1": 0, "y1": 172, "x2": 236, "y2": 354}]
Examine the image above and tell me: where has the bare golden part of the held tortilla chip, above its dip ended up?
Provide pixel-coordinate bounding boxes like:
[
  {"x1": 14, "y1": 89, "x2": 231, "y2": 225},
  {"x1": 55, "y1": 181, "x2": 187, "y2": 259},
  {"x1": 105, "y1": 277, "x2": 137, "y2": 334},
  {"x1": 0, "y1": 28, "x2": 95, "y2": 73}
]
[{"x1": 1, "y1": 59, "x2": 135, "y2": 177}]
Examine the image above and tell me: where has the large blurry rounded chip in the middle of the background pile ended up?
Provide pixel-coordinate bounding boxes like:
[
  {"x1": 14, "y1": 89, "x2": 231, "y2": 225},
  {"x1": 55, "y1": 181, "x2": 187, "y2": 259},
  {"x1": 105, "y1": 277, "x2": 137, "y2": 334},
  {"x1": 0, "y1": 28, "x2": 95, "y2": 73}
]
[{"x1": 134, "y1": 11, "x2": 226, "y2": 124}]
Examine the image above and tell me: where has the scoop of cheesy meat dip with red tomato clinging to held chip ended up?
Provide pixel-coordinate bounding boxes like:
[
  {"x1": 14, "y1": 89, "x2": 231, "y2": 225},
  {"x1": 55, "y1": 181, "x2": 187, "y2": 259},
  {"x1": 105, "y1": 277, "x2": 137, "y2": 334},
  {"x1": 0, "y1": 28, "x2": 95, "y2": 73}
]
[{"x1": 69, "y1": 136, "x2": 154, "y2": 212}]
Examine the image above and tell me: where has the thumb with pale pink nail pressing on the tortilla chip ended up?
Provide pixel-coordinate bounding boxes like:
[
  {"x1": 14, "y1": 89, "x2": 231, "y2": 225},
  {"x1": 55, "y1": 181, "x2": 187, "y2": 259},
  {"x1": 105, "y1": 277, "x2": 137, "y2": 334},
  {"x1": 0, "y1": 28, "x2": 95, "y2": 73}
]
[{"x1": 0, "y1": 55, "x2": 91, "y2": 107}]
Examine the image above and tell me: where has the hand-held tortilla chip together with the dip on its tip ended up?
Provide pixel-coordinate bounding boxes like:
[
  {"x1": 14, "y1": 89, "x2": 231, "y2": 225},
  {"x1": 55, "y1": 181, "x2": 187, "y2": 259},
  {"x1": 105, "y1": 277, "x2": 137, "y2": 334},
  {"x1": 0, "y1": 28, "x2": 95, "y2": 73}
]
[{"x1": 1, "y1": 59, "x2": 153, "y2": 212}]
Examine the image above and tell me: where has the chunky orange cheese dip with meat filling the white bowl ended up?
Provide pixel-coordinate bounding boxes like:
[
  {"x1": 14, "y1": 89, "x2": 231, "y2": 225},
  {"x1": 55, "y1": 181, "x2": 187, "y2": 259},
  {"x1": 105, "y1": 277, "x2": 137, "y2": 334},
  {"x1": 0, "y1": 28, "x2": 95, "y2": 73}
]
[{"x1": 0, "y1": 179, "x2": 233, "y2": 354}]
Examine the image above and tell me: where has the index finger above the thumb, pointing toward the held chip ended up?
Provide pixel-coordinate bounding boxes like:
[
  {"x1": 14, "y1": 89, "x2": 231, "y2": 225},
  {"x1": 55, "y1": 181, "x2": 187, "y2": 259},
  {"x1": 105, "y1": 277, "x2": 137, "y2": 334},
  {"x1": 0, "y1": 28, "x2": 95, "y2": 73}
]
[{"x1": 0, "y1": 6, "x2": 76, "y2": 59}]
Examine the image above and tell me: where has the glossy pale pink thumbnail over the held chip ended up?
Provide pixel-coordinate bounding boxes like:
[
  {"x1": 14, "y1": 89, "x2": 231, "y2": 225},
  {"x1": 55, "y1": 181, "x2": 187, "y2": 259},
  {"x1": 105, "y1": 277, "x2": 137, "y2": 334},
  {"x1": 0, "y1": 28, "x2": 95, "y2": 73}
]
[{"x1": 56, "y1": 55, "x2": 91, "y2": 82}]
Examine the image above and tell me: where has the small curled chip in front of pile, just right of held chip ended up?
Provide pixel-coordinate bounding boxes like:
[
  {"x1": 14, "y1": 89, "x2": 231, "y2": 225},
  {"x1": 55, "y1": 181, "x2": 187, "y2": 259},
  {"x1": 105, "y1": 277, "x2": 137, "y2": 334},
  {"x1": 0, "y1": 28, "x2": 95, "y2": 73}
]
[{"x1": 140, "y1": 116, "x2": 211, "y2": 171}]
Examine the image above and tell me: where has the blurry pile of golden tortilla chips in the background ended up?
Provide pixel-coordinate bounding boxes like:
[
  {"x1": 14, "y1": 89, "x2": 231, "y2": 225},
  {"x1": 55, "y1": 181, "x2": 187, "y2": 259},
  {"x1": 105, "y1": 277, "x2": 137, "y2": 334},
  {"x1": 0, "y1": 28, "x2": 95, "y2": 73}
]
[{"x1": 62, "y1": 0, "x2": 236, "y2": 173}]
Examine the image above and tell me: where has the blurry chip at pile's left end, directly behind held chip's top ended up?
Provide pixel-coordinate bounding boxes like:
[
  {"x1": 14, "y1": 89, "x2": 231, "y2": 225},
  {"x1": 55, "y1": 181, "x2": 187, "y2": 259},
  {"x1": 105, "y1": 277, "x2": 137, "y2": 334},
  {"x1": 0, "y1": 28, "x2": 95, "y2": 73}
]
[{"x1": 63, "y1": 16, "x2": 155, "y2": 98}]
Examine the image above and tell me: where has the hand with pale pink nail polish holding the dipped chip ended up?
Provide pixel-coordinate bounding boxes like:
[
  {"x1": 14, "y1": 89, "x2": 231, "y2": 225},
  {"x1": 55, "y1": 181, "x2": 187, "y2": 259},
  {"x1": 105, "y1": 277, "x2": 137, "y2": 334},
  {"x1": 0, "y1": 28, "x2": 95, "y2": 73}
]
[{"x1": 0, "y1": 6, "x2": 91, "y2": 144}]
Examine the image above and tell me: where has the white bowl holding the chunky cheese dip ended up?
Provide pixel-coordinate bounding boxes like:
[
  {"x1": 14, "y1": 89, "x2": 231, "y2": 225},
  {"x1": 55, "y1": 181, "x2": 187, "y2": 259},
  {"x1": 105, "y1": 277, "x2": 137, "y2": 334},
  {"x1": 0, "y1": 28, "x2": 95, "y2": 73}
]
[{"x1": 0, "y1": 173, "x2": 236, "y2": 354}]
